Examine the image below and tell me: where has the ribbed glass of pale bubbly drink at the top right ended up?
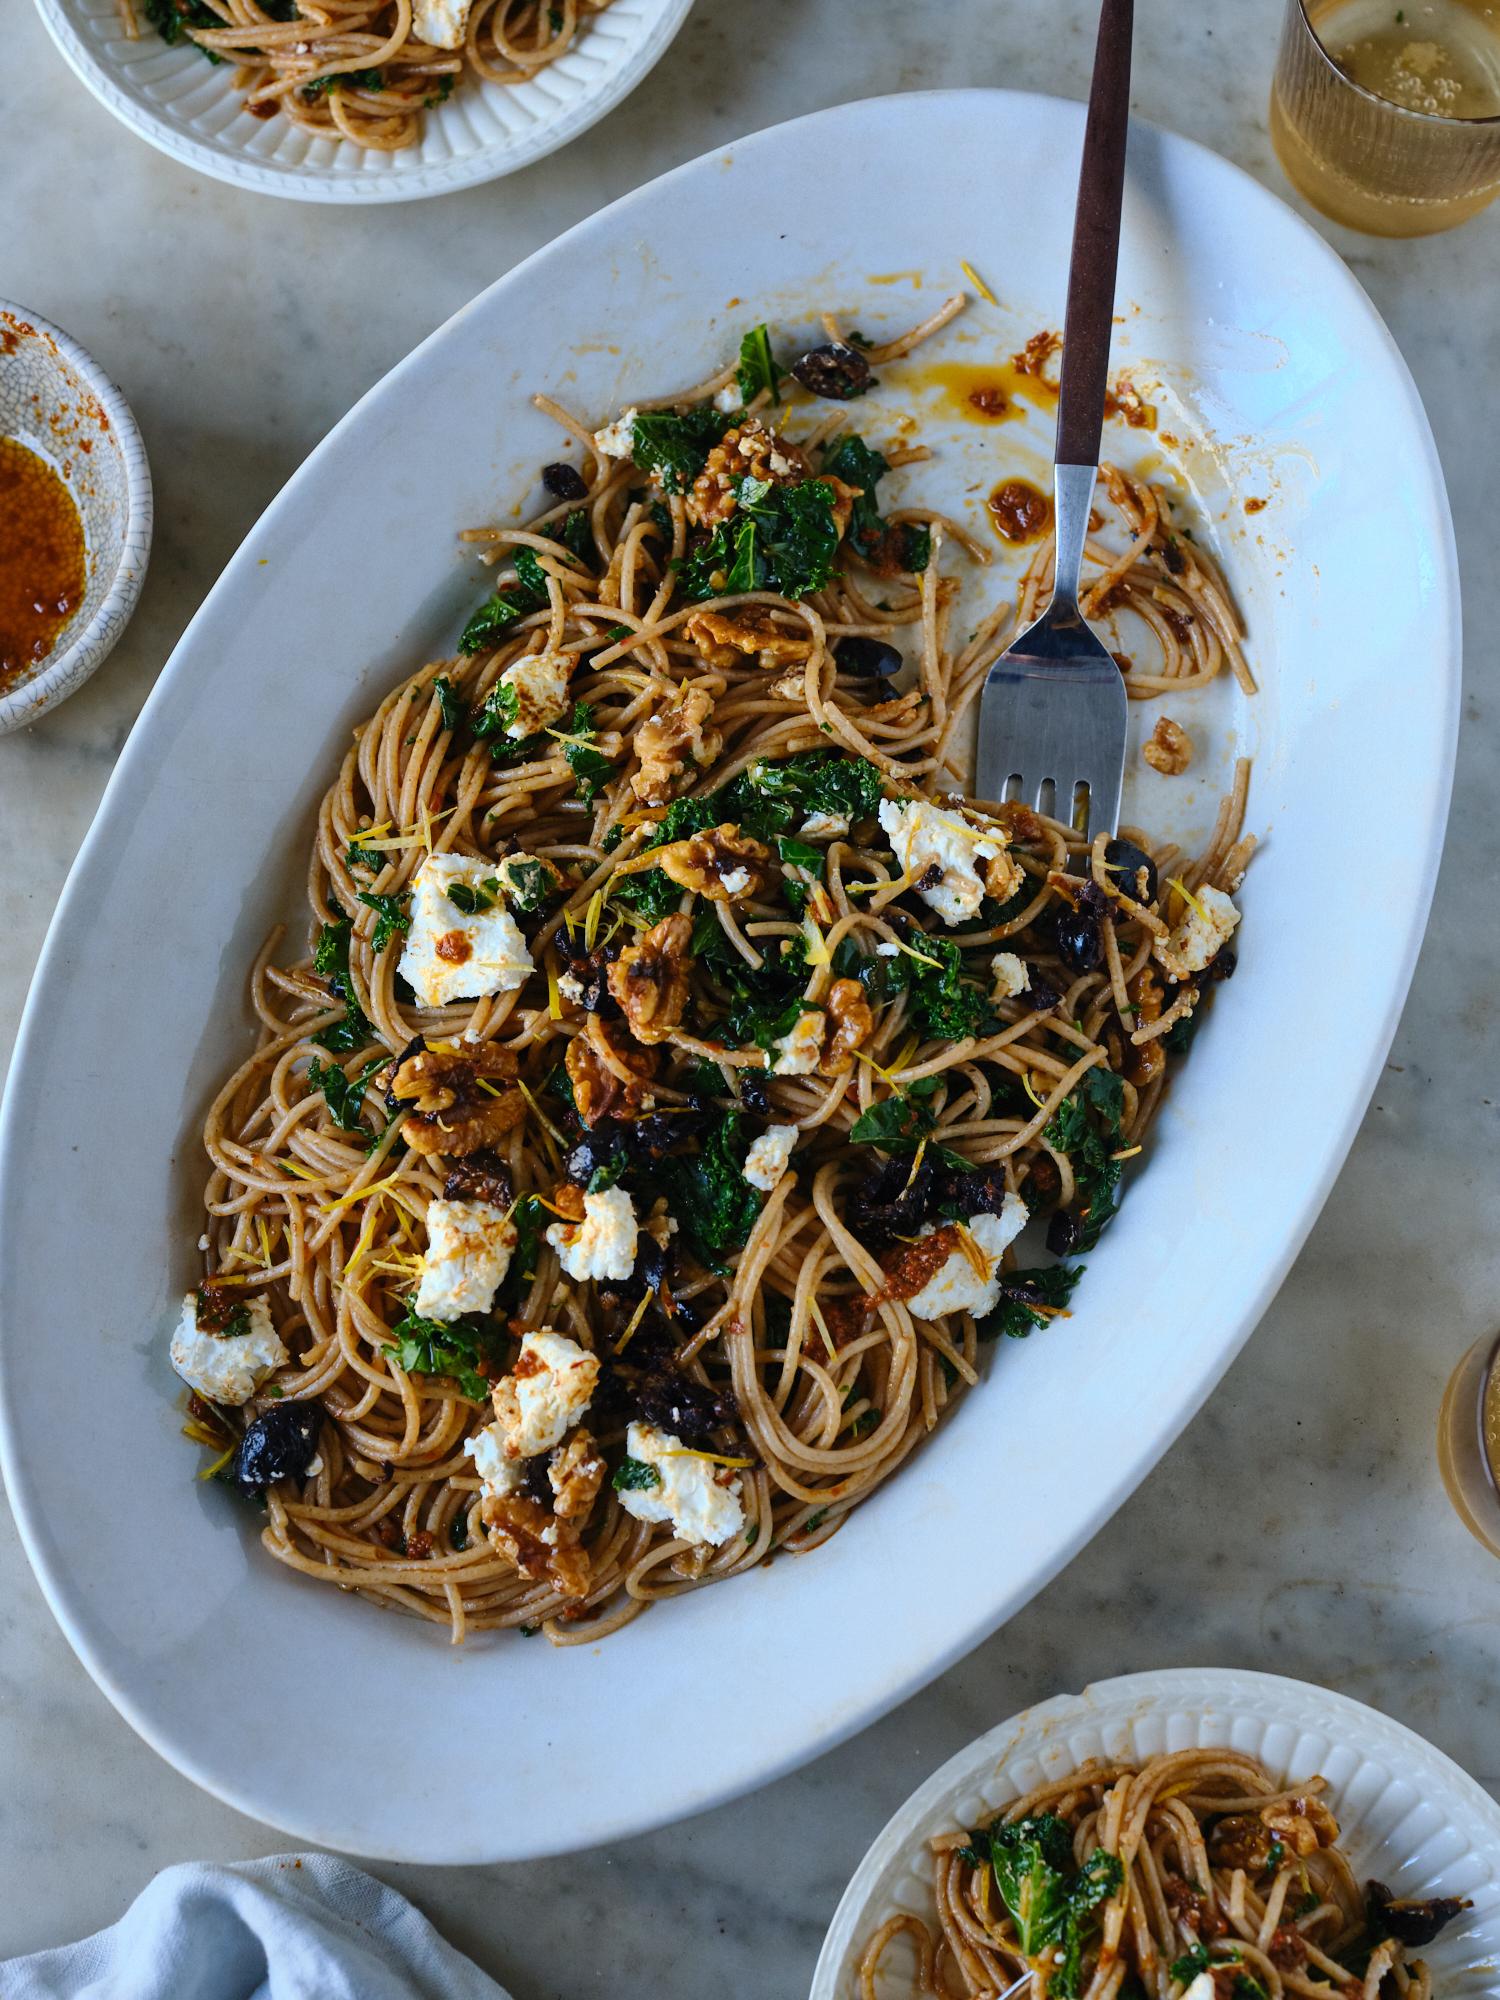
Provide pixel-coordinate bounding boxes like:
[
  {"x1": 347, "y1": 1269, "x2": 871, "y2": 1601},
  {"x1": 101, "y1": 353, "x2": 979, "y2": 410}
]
[{"x1": 1270, "y1": 0, "x2": 1500, "y2": 236}]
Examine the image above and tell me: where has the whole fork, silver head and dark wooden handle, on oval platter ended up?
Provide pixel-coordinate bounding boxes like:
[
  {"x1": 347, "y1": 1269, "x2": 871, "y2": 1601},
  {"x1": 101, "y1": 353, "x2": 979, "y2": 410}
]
[{"x1": 976, "y1": 0, "x2": 1134, "y2": 836}]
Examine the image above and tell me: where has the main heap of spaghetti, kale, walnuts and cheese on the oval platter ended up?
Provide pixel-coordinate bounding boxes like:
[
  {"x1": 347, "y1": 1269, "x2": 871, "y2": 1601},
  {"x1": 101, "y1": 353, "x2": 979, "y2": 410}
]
[{"x1": 172, "y1": 308, "x2": 1254, "y2": 1644}]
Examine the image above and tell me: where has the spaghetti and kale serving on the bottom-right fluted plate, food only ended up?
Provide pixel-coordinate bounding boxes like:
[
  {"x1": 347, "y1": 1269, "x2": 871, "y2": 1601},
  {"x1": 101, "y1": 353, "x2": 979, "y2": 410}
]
[{"x1": 860, "y1": 1750, "x2": 1468, "y2": 2000}]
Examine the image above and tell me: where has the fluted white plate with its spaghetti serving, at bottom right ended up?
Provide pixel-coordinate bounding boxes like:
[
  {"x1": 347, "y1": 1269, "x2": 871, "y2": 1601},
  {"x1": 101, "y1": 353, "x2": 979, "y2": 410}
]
[{"x1": 812, "y1": 1668, "x2": 1500, "y2": 2000}]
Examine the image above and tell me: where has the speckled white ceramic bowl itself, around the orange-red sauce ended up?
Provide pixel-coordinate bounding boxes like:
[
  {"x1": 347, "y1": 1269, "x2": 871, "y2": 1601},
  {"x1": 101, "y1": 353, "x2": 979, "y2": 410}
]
[{"x1": 0, "y1": 298, "x2": 152, "y2": 736}]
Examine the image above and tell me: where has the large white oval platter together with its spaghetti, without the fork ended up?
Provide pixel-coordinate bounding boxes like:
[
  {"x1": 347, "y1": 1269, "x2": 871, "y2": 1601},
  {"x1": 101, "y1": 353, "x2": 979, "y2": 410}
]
[{"x1": 0, "y1": 92, "x2": 1456, "y2": 1860}]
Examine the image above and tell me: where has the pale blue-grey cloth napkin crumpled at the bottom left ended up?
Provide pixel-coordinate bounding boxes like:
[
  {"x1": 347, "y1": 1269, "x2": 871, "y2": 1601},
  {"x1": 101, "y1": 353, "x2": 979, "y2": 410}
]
[{"x1": 0, "y1": 1854, "x2": 510, "y2": 2000}]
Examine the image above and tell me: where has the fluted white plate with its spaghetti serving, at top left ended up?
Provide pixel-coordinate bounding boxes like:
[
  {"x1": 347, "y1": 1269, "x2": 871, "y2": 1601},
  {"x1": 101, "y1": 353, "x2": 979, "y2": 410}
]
[{"x1": 36, "y1": 0, "x2": 692, "y2": 202}]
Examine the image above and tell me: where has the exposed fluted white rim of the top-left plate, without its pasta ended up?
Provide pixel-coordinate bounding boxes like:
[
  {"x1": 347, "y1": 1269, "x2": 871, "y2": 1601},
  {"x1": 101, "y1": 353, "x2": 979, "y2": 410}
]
[{"x1": 36, "y1": 0, "x2": 692, "y2": 202}]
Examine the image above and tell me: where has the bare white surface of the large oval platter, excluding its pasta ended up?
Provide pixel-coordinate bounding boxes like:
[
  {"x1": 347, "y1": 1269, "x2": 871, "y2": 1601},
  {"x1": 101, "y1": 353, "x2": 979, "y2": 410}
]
[{"x1": 0, "y1": 92, "x2": 1458, "y2": 1862}]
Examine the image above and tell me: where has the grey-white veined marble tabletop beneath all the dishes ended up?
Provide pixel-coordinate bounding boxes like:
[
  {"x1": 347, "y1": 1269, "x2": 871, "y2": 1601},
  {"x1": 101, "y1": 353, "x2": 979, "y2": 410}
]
[{"x1": 0, "y1": 0, "x2": 1500, "y2": 2000}]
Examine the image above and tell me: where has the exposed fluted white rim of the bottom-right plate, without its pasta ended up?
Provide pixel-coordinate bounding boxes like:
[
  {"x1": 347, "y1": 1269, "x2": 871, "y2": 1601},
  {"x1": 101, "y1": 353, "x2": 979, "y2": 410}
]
[{"x1": 824, "y1": 1666, "x2": 1500, "y2": 2000}]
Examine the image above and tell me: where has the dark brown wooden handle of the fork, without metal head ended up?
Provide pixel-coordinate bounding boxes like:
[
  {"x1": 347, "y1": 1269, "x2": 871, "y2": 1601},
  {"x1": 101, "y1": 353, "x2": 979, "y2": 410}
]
[{"x1": 1056, "y1": 0, "x2": 1134, "y2": 466}]
